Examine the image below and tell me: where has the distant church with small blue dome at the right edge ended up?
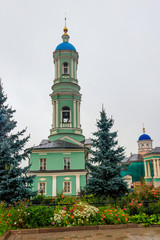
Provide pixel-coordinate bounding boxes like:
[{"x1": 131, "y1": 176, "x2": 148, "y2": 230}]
[{"x1": 121, "y1": 126, "x2": 160, "y2": 187}]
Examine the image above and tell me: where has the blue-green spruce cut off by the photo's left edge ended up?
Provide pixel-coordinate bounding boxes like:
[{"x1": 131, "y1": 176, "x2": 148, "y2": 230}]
[{"x1": 0, "y1": 82, "x2": 36, "y2": 204}]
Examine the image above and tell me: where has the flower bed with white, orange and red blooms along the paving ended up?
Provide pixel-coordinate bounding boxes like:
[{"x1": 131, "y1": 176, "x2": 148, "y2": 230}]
[{"x1": 0, "y1": 186, "x2": 160, "y2": 235}]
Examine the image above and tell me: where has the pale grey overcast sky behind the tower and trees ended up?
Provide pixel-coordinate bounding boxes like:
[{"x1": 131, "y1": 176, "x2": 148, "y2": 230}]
[{"x1": 0, "y1": 0, "x2": 160, "y2": 166}]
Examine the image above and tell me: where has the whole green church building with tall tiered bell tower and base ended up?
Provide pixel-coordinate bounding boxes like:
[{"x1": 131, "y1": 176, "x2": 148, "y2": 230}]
[{"x1": 28, "y1": 18, "x2": 90, "y2": 196}]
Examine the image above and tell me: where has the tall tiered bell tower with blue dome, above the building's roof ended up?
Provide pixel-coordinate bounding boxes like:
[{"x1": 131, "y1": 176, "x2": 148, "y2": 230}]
[{"x1": 49, "y1": 18, "x2": 84, "y2": 143}]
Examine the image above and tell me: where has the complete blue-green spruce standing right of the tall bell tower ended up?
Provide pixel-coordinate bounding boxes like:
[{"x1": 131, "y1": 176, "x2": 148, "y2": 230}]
[{"x1": 86, "y1": 109, "x2": 128, "y2": 198}]
